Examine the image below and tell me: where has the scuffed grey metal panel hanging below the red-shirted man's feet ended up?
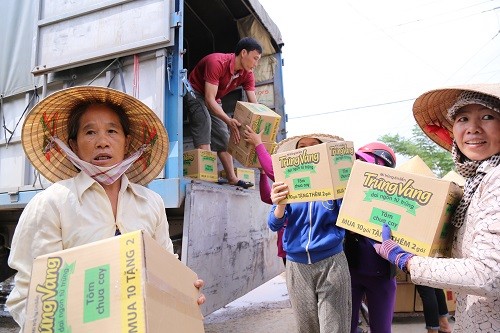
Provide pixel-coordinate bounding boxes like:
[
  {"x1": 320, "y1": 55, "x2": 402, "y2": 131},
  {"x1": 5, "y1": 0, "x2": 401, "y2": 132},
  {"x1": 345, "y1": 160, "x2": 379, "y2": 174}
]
[{"x1": 182, "y1": 182, "x2": 283, "y2": 315}]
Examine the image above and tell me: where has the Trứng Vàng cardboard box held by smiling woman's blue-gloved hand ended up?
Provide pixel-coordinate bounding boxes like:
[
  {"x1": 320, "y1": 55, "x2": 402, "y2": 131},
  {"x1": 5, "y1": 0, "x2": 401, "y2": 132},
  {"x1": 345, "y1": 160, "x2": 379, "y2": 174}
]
[{"x1": 337, "y1": 161, "x2": 462, "y2": 256}]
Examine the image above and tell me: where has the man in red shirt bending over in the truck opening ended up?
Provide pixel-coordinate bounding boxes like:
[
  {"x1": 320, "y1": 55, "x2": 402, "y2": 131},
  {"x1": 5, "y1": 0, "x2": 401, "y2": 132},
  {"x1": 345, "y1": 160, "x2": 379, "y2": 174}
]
[{"x1": 185, "y1": 37, "x2": 262, "y2": 188}]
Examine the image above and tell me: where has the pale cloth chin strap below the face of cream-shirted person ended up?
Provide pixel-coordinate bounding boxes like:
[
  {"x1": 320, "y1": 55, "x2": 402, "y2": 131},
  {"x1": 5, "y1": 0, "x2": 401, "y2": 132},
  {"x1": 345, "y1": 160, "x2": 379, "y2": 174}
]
[{"x1": 53, "y1": 138, "x2": 147, "y2": 185}]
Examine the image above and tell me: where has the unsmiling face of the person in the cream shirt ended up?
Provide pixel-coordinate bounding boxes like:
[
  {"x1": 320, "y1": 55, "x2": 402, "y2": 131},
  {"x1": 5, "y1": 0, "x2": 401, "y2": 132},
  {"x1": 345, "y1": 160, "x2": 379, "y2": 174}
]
[{"x1": 70, "y1": 105, "x2": 130, "y2": 167}]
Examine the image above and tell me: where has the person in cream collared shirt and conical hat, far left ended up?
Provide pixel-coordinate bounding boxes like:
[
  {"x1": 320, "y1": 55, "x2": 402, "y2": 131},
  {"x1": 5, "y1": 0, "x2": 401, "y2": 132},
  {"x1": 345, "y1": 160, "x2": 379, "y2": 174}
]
[{"x1": 6, "y1": 86, "x2": 205, "y2": 327}]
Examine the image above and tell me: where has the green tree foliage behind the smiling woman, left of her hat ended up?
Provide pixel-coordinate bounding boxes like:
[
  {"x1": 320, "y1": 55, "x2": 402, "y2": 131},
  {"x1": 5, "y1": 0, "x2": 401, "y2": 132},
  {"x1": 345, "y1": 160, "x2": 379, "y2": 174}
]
[{"x1": 378, "y1": 125, "x2": 454, "y2": 177}]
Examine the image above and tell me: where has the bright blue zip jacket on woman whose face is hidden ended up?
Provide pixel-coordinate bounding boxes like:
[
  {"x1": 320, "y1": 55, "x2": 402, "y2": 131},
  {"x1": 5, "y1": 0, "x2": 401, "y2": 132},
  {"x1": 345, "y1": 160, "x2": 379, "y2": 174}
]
[{"x1": 267, "y1": 200, "x2": 345, "y2": 264}]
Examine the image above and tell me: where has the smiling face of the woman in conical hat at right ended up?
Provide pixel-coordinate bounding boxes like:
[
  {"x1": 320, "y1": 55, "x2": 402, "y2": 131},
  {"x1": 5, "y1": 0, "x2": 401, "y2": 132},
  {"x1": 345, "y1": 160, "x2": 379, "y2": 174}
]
[{"x1": 453, "y1": 104, "x2": 500, "y2": 161}]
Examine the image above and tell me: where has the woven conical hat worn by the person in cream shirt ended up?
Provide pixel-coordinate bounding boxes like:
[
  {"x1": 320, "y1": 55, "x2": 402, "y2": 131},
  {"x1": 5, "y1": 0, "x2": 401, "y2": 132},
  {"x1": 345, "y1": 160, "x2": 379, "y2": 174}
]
[{"x1": 22, "y1": 86, "x2": 168, "y2": 185}]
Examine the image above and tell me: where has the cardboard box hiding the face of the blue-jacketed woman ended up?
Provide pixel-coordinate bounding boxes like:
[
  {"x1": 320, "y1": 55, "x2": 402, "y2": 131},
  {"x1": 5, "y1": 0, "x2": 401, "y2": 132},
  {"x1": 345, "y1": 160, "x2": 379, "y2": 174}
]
[{"x1": 272, "y1": 141, "x2": 354, "y2": 203}]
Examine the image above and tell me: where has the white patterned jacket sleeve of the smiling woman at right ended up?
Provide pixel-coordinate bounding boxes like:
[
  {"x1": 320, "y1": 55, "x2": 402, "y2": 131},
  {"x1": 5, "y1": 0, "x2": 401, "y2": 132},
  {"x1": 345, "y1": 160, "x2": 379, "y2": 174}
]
[{"x1": 410, "y1": 167, "x2": 500, "y2": 297}]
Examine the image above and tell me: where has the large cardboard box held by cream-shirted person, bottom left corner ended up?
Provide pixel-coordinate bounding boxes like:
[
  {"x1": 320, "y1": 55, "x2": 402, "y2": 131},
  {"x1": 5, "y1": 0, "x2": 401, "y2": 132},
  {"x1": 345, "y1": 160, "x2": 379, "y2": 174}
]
[{"x1": 23, "y1": 231, "x2": 204, "y2": 333}]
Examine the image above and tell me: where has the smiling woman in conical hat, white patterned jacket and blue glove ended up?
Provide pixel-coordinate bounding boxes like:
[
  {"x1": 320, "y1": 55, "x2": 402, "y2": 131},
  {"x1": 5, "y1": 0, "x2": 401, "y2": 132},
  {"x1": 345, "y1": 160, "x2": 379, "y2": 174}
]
[{"x1": 375, "y1": 84, "x2": 500, "y2": 333}]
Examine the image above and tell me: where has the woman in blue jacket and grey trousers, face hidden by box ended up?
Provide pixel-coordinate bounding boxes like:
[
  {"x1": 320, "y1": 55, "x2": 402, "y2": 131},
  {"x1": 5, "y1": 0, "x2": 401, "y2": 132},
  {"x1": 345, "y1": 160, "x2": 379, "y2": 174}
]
[{"x1": 268, "y1": 134, "x2": 351, "y2": 333}]
